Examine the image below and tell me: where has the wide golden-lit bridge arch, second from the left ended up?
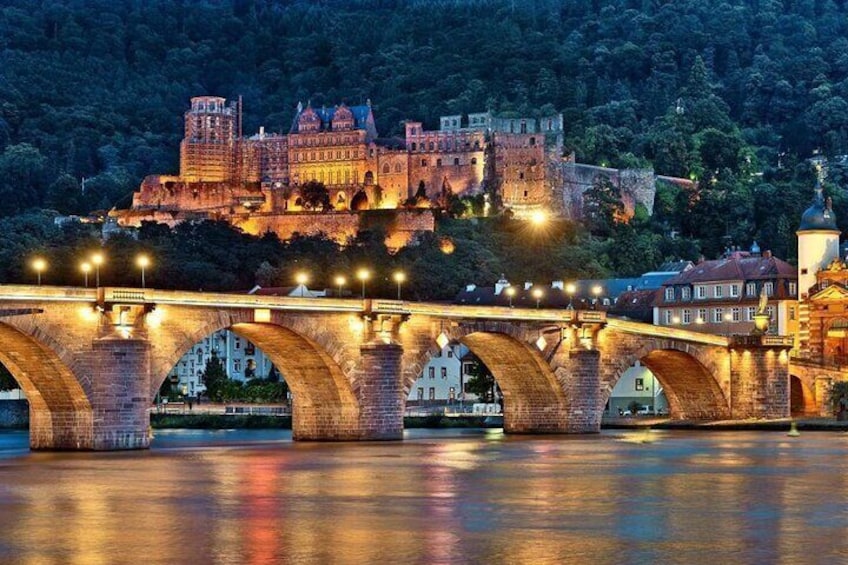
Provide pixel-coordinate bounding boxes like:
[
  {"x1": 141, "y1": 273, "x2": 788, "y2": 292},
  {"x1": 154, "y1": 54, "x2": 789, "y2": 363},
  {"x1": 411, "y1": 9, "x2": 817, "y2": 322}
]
[{"x1": 151, "y1": 309, "x2": 360, "y2": 440}]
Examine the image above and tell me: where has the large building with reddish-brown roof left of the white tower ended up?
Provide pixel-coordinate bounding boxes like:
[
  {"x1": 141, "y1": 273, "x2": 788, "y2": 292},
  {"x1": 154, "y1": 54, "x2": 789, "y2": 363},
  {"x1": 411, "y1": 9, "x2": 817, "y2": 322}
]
[{"x1": 653, "y1": 248, "x2": 799, "y2": 335}]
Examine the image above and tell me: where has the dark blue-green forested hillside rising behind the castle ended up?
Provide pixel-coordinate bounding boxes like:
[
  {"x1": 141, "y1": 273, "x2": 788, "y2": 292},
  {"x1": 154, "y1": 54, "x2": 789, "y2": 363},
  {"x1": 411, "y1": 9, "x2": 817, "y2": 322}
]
[{"x1": 0, "y1": 0, "x2": 848, "y2": 268}]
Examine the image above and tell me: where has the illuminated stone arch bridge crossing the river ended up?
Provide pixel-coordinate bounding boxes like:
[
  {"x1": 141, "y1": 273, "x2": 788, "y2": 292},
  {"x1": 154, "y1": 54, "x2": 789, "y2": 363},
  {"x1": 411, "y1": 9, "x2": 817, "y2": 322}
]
[{"x1": 0, "y1": 285, "x2": 791, "y2": 450}]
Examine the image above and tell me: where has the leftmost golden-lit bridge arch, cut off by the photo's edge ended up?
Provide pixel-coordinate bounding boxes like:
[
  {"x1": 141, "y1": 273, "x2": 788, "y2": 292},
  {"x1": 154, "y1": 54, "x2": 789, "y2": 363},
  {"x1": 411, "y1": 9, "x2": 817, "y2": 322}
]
[{"x1": 0, "y1": 322, "x2": 94, "y2": 449}]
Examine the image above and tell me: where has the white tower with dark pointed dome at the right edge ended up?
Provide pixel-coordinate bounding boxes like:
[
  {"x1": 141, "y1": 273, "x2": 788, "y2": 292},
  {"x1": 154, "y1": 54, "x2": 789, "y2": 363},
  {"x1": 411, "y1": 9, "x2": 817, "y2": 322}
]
[{"x1": 795, "y1": 183, "x2": 839, "y2": 300}]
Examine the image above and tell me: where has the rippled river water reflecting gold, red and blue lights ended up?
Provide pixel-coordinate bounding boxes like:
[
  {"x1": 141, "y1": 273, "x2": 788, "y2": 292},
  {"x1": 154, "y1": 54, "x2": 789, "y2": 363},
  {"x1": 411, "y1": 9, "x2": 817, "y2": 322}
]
[{"x1": 0, "y1": 430, "x2": 848, "y2": 564}]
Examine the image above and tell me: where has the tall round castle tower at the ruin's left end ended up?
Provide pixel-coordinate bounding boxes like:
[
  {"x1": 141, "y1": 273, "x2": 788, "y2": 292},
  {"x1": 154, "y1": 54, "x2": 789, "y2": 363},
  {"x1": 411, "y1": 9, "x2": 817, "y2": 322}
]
[{"x1": 180, "y1": 96, "x2": 237, "y2": 182}]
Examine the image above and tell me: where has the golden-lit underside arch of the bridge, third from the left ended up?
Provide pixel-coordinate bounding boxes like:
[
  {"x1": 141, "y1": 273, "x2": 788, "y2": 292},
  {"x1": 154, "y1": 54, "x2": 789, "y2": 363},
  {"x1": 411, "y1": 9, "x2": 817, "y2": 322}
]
[{"x1": 403, "y1": 322, "x2": 568, "y2": 433}]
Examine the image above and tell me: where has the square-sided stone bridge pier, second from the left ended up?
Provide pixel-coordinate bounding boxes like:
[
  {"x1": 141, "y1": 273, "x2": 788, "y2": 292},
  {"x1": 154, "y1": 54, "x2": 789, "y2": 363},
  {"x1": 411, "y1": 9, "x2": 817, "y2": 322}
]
[{"x1": 359, "y1": 341, "x2": 404, "y2": 440}]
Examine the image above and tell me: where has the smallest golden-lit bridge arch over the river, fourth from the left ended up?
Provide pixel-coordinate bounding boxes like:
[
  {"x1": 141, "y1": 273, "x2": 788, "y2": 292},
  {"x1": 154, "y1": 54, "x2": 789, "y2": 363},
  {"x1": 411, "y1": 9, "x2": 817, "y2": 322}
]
[{"x1": 602, "y1": 337, "x2": 730, "y2": 420}]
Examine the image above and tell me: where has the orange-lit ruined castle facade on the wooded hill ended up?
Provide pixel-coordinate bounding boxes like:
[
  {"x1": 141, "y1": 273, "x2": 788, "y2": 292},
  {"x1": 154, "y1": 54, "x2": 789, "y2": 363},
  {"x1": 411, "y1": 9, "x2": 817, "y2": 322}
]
[{"x1": 132, "y1": 96, "x2": 563, "y2": 223}]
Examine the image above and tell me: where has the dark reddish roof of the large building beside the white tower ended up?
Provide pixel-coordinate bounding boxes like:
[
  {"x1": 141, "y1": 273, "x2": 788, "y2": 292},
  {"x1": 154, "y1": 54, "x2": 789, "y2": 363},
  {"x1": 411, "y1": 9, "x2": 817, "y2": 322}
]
[{"x1": 663, "y1": 254, "x2": 798, "y2": 286}]
